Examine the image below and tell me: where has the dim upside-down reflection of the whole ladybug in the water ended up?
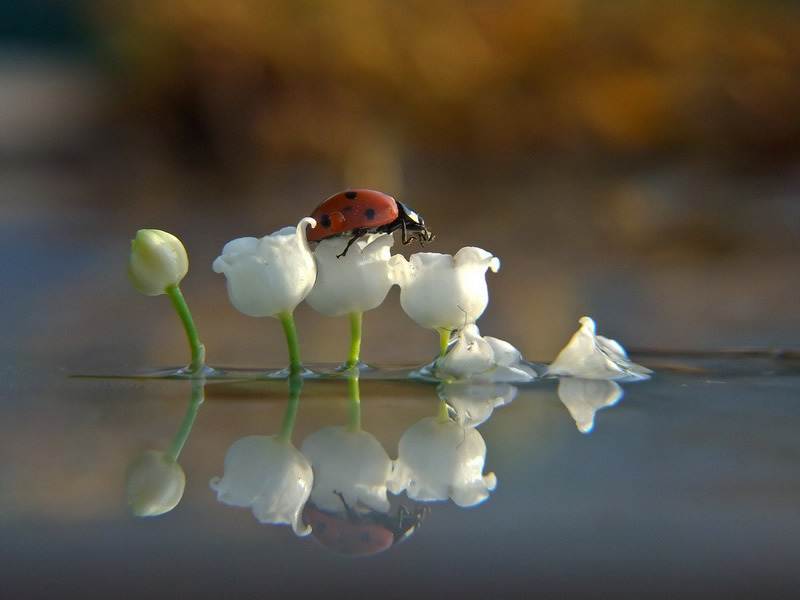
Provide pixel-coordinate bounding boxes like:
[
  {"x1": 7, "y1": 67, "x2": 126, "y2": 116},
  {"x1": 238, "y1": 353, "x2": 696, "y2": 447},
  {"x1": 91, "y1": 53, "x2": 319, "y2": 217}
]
[{"x1": 303, "y1": 494, "x2": 428, "y2": 556}]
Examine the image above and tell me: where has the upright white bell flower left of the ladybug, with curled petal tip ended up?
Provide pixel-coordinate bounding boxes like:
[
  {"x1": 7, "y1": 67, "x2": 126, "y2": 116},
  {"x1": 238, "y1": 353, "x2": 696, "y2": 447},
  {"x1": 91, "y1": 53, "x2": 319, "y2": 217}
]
[{"x1": 213, "y1": 217, "x2": 317, "y2": 317}]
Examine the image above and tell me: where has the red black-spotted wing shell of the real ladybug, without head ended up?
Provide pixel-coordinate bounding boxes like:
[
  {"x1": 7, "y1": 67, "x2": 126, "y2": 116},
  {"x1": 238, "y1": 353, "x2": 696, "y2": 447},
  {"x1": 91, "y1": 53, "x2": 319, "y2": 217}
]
[{"x1": 308, "y1": 189, "x2": 400, "y2": 242}]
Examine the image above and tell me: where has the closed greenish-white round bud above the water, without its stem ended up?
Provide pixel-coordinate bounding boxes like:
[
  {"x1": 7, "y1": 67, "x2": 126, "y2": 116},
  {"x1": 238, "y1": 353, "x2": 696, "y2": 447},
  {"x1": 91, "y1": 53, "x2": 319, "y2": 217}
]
[{"x1": 128, "y1": 229, "x2": 189, "y2": 296}]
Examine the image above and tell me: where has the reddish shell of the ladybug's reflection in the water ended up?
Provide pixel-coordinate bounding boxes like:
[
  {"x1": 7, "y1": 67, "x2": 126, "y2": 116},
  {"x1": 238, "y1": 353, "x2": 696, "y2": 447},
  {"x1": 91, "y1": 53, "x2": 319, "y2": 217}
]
[{"x1": 303, "y1": 505, "x2": 394, "y2": 556}]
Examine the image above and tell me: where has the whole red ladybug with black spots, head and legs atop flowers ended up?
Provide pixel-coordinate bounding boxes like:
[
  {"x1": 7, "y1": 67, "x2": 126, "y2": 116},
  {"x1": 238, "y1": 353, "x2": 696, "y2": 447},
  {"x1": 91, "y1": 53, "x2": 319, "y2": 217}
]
[{"x1": 308, "y1": 189, "x2": 434, "y2": 258}]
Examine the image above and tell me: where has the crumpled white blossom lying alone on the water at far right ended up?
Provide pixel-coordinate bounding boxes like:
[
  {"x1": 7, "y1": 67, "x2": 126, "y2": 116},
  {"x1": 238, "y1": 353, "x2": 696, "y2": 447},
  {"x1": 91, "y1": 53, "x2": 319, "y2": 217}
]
[{"x1": 547, "y1": 317, "x2": 652, "y2": 381}]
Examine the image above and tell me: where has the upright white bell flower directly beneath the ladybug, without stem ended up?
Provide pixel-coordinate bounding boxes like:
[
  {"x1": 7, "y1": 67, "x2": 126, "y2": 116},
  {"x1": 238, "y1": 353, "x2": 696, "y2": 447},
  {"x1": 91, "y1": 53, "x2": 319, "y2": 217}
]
[{"x1": 306, "y1": 233, "x2": 394, "y2": 317}]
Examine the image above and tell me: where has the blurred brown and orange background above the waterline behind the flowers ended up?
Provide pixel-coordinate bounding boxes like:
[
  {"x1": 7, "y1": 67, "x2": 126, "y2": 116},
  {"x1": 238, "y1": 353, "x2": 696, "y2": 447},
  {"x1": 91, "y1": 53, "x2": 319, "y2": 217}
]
[{"x1": 0, "y1": 0, "x2": 800, "y2": 371}]
